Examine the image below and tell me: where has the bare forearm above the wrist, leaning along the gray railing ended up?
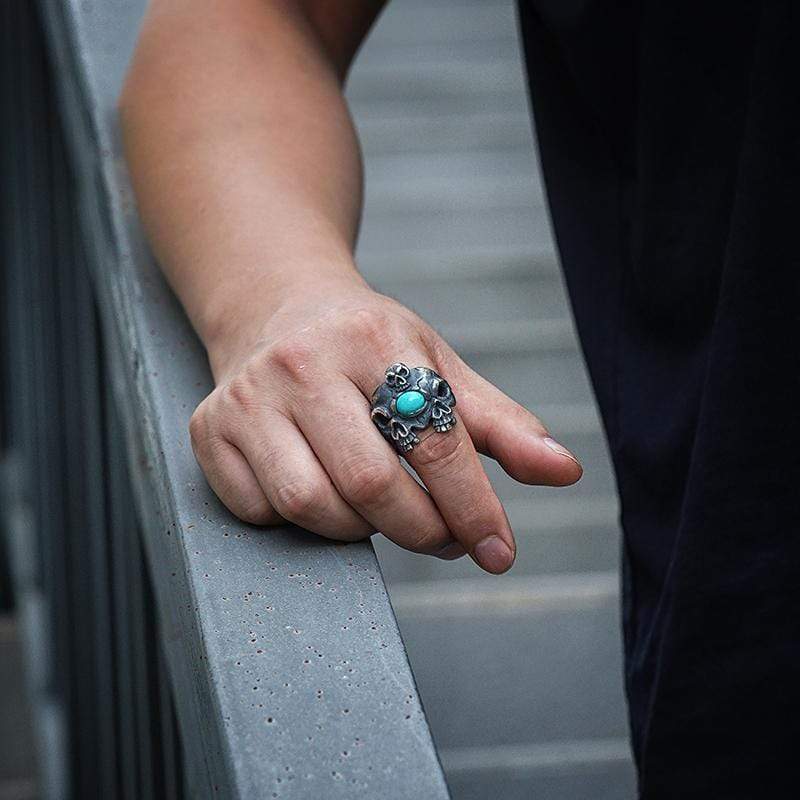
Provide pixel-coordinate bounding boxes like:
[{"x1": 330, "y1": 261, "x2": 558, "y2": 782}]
[{"x1": 121, "y1": 0, "x2": 380, "y2": 376}]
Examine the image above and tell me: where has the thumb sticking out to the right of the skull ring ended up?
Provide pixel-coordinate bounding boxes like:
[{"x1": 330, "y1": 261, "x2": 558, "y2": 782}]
[{"x1": 442, "y1": 354, "x2": 583, "y2": 486}]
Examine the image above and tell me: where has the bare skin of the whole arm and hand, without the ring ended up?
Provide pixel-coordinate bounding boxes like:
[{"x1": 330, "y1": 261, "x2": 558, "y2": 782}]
[{"x1": 120, "y1": 0, "x2": 581, "y2": 573}]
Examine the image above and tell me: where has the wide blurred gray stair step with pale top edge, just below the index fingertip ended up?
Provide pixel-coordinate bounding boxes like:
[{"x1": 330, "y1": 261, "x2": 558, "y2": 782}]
[{"x1": 390, "y1": 572, "x2": 627, "y2": 748}]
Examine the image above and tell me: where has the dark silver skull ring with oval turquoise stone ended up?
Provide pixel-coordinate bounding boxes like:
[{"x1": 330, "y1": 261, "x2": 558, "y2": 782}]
[{"x1": 371, "y1": 362, "x2": 456, "y2": 455}]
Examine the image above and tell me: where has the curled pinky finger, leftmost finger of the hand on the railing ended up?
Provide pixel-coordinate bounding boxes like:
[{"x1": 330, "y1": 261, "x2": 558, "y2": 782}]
[{"x1": 193, "y1": 438, "x2": 287, "y2": 525}]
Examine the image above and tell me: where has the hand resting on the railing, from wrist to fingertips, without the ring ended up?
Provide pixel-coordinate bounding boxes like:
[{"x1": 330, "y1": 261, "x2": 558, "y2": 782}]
[{"x1": 190, "y1": 282, "x2": 582, "y2": 573}]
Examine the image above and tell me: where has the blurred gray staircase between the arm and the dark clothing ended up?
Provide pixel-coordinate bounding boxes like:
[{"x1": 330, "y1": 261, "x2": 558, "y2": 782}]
[{"x1": 348, "y1": 0, "x2": 635, "y2": 800}]
